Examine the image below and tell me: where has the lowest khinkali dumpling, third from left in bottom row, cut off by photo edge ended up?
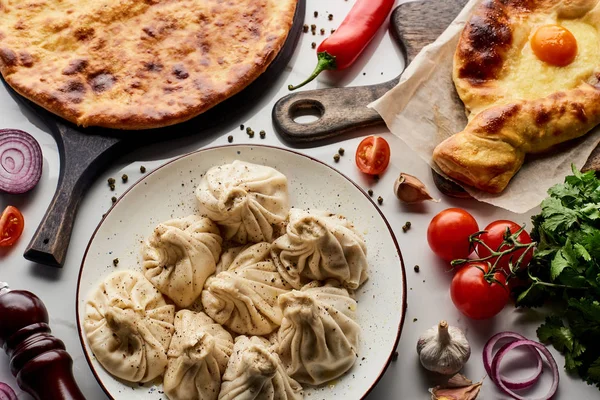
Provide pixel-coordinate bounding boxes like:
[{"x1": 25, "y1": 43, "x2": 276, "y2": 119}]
[{"x1": 219, "y1": 336, "x2": 304, "y2": 400}]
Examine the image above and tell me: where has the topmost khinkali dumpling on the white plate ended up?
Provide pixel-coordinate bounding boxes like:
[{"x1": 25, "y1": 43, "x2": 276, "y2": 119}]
[{"x1": 196, "y1": 160, "x2": 290, "y2": 244}]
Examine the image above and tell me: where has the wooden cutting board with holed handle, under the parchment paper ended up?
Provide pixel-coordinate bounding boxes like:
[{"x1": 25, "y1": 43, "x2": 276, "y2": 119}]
[{"x1": 272, "y1": 0, "x2": 600, "y2": 198}]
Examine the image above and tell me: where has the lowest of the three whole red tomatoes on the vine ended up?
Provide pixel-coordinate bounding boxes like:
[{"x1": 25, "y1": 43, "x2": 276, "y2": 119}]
[{"x1": 450, "y1": 262, "x2": 510, "y2": 319}]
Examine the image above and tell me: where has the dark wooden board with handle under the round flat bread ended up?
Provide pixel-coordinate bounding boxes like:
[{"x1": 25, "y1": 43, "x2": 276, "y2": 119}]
[{"x1": 4, "y1": 0, "x2": 306, "y2": 267}]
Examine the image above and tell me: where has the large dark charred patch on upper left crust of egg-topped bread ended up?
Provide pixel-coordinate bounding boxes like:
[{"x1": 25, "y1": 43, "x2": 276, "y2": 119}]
[{"x1": 457, "y1": 0, "x2": 512, "y2": 84}]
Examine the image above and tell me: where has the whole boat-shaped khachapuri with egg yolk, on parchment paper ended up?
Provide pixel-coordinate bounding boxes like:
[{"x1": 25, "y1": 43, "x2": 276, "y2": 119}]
[{"x1": 433, "y1": 0, "x2": 600, "y2": 193}]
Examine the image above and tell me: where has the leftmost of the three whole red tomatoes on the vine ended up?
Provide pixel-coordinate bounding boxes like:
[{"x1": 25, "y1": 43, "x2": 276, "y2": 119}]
[{"x1": 427, "y1": 208, "x2": 479, "y2": 261}]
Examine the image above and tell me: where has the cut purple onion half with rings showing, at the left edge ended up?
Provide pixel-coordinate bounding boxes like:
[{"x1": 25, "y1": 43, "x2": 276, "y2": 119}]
[{"x1": 0, "y1": 129, "x2": 43, "y2": 194}]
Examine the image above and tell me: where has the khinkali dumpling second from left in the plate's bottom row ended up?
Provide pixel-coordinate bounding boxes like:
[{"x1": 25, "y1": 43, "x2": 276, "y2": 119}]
[{"x1": 163, "y1": 310, "x2": 233, "y2": 400}]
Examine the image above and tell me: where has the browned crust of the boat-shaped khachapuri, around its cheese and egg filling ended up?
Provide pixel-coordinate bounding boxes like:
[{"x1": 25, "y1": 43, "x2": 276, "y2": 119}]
[{"x1": 433, "y1": 0, "x2": 600, "y2": 193}]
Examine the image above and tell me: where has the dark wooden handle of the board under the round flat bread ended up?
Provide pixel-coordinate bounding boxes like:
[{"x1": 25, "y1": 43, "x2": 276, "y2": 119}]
[{"x1": 23, "y1": 124, "x2": 127, "y2": 268}]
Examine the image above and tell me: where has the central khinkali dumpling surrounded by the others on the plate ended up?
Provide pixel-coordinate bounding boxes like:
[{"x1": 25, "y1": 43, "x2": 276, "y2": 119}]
[{"x1": 202, "y1": 242, "x2": 292, "y2": 335}]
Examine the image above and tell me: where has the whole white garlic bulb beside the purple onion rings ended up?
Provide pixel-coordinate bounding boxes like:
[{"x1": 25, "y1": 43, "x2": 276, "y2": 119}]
[{"x1": 417, "y1": 321, "x2": 471, "y2": 375}]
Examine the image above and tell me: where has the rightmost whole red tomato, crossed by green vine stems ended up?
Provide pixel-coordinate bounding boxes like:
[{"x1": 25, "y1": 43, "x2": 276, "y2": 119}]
[{"x1": 477, "y1": 220, "x2": 533, "y2": 274}]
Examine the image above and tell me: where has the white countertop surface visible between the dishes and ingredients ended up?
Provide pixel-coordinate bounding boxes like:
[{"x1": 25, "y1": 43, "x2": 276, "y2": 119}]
[{"x1": 0, "y1": 0, "x2": 600, "y2": 400}]
